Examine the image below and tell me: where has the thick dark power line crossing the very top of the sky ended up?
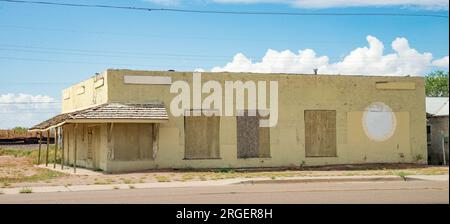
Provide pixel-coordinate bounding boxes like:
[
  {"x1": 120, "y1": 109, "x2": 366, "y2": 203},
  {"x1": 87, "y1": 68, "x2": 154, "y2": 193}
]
[{"x1": 0, "y1": 0, "x2": 448, "y2": 18}]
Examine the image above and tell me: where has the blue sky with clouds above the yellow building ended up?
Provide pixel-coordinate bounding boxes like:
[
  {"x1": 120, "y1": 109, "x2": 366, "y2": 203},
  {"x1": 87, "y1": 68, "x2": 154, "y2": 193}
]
[{"x1": 0, "y1": 0, "x2": 449, "y2": 128}]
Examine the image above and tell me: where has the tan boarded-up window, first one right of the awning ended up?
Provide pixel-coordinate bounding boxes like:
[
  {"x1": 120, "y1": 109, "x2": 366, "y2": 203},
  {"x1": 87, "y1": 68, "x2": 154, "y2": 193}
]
[{"x1": 184, "y1": 114, "x2": 220, "y2": 159}]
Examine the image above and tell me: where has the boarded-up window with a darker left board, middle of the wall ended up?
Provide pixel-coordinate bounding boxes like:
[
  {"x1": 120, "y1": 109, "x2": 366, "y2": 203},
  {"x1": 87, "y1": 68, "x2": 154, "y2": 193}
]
[{"x1": 236, "y1": 111, "x2": 270, "y2": 158}]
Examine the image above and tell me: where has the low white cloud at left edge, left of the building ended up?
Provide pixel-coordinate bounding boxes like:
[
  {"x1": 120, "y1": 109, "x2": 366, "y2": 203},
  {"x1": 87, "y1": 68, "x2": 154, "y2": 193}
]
[{"x1": 0, "y1": 93, "x2": 60, "y2": 129}]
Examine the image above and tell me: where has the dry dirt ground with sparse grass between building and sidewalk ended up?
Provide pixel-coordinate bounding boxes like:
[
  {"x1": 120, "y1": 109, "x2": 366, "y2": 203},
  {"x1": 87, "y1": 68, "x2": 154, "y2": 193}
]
[{"x1": 0, "y1": 146, "x2": 449, "y2": 188}]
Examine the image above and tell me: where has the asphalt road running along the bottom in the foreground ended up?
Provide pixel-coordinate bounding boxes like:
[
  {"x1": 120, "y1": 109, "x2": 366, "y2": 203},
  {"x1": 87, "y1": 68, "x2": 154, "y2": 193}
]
[{"x1": 0, "y1": 181, "x2": 449, "y2": 204}]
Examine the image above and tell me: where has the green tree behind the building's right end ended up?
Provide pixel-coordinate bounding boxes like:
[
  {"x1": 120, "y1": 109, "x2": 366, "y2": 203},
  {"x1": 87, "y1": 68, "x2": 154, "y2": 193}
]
[{"x1": 425, "y1": 71, "x2": 448, "y2": 97}]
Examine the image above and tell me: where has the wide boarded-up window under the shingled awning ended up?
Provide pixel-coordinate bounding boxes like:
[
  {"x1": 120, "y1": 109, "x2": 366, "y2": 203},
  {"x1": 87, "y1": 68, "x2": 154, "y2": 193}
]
[{"x1": 113, "y1": 124, "x2": 153, "y2": 160}]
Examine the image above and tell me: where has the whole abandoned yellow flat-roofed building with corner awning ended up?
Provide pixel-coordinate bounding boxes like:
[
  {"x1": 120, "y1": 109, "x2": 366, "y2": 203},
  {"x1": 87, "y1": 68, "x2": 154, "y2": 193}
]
[{"x1": 31, "y1": 69, "x2": 427, "y2": 172}]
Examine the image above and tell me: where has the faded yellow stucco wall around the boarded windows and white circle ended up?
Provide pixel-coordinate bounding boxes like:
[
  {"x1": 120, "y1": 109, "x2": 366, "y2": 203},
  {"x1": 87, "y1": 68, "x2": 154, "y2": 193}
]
[{"x1": 59, "y1": 70, "x2": 427, "y2": 172}]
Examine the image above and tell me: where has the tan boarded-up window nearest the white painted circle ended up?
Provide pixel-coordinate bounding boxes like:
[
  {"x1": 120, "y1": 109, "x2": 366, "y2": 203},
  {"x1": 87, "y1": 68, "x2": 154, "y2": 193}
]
[{"x1": 305, "y1": 110, "x2": 337, "y2": 157}]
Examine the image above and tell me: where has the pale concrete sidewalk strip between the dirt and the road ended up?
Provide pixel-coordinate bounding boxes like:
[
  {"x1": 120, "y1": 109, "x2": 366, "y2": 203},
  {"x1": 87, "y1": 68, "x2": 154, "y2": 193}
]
[{"x1": 0, "y1": 175, "x2": 449, "y2": 195}]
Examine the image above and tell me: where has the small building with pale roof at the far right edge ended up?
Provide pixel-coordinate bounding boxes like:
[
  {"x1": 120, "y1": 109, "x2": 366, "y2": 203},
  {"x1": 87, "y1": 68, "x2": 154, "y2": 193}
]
[{"x1": 426, "y1": 97, "x2": 449, "y2": 165}]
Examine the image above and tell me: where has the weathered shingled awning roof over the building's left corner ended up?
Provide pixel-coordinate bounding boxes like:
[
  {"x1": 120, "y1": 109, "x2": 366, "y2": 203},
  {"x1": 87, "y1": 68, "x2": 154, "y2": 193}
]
[{"x1": 29, "y1": 103, "x2": 169, "y2": 131}]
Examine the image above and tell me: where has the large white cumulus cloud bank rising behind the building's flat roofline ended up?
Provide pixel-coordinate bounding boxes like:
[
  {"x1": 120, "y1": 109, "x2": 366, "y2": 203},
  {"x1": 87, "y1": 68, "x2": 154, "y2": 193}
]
[{"x1": 211, "y1": 36, "x2": 448, "y2": 76}]
